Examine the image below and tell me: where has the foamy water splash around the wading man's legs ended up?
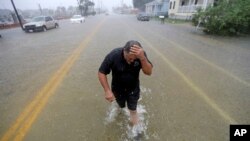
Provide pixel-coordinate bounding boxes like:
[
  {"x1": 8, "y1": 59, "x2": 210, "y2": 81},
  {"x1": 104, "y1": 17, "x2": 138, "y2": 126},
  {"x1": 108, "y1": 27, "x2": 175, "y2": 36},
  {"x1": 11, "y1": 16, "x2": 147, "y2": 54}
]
[{"x1": 104, "y1": 86, "x2": 151, "y2": 141}]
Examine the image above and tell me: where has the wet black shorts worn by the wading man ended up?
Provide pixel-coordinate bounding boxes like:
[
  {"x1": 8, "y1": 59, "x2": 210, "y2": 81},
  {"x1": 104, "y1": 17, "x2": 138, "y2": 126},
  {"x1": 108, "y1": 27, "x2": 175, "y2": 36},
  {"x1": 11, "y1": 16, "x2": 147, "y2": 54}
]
[{"x1": 112, "y1": 89, "x2": 140, "y2": 111}]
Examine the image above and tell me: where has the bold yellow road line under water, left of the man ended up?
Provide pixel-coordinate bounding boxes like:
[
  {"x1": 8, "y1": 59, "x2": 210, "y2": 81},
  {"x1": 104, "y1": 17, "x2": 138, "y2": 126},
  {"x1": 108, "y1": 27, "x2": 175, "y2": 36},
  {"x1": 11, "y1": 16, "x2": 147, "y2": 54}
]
[{"x1": 0, "y1": 18, "x2": 104, "y2": 141}]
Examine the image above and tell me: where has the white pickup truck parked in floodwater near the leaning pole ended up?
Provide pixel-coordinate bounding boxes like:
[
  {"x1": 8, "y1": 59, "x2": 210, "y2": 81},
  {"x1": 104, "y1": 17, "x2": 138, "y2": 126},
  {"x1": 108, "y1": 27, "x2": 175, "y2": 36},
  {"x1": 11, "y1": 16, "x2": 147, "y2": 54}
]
[{"x1": 23, "y1": 16, "x2": 59, "y2": 32}]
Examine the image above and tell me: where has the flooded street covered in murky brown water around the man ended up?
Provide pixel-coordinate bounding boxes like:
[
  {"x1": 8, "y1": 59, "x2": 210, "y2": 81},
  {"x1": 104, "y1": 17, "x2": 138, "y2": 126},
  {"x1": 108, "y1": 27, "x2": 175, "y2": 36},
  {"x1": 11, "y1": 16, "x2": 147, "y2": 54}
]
[{"x1": 0, "y1": 15, "x2": 250, "y2": 141}]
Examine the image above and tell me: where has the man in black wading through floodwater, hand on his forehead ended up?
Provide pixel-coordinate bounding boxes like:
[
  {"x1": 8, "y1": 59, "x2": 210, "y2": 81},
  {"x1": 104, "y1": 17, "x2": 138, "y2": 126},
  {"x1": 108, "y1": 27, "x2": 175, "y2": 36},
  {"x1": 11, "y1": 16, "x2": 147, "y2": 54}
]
[{"x1": 98, "y1": 41, "x2": 153, "y2": 126}]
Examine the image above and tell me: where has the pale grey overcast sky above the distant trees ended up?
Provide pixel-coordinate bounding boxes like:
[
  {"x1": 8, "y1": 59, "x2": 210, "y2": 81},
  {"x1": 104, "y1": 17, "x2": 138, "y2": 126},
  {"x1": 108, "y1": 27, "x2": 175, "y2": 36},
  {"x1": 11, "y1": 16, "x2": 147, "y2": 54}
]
[{"x1": 0, "y1": 0, "x2": 132, "y2": 10}]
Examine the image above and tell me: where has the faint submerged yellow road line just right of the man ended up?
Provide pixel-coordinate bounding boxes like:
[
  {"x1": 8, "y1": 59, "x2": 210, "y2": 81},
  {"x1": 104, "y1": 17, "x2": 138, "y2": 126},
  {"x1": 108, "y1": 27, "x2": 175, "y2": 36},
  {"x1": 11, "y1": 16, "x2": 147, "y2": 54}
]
[{"x1": 128, "y1": 26, "x2": 237, "y2": 124}]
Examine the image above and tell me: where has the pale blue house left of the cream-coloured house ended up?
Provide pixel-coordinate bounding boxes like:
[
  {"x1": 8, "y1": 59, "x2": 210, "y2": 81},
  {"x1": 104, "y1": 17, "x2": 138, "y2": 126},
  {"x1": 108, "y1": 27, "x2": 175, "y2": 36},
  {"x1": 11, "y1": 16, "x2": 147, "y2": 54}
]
[{"x1": 145, "y1": 0, "x2": 170, "y2": 16}]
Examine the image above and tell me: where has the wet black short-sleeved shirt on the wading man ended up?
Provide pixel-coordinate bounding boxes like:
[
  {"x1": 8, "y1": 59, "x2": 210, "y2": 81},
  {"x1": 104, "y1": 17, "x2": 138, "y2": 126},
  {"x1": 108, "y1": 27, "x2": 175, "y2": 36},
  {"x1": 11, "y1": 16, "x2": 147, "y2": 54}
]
[{"x1": 99, "y1": 48, "x2": 150, "y2": 91}]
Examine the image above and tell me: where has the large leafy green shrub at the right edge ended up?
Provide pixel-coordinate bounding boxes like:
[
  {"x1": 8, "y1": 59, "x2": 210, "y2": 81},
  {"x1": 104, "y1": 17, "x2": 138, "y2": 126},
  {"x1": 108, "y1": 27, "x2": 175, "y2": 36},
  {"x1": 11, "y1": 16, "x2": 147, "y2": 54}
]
[{"x1": 192, "y1": 0, "x2": 250, "y2": 35}]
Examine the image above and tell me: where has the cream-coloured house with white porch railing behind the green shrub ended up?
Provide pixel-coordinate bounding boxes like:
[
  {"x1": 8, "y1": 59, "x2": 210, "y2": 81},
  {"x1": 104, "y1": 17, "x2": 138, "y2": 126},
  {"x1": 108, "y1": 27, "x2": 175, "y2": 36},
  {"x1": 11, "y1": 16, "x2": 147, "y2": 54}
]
[{"x1": 168, "y1": 0, "x2": 217, "y2": 20}]
